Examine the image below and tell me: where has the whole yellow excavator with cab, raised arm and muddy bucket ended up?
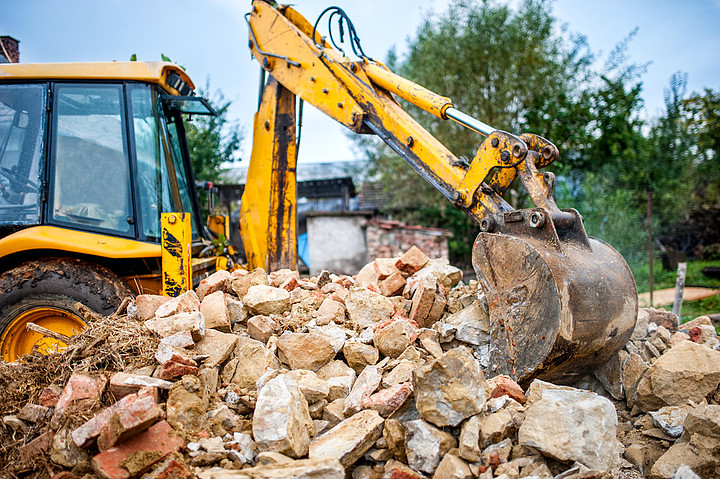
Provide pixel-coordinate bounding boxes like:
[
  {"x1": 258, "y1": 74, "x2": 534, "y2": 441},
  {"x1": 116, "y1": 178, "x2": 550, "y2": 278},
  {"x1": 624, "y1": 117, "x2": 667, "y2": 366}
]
[{"x1": 0, "y1": 0, "x2": 637, "y2": 383}]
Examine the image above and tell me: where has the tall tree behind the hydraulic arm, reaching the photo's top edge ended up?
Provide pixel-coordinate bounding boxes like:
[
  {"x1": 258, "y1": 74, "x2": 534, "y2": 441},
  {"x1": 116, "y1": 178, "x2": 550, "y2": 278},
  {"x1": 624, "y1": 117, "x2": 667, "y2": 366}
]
[{"x1": 358, "y1": 0, "x2": 593, "y2": 262}]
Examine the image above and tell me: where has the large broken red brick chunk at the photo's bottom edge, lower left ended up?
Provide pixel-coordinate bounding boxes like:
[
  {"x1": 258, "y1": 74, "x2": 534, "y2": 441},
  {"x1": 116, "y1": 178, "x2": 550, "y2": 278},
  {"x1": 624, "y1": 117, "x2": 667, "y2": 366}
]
[{"x1": 92, "y1": 421, "x2": 185, "y2": 479}]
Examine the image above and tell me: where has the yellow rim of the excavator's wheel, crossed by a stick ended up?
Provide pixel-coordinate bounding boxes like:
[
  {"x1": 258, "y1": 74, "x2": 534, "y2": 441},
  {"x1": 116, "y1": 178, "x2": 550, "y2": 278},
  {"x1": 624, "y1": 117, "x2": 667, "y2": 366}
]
[{"x1": 0, "y1": 306, "x2": 85, "y2": 362}]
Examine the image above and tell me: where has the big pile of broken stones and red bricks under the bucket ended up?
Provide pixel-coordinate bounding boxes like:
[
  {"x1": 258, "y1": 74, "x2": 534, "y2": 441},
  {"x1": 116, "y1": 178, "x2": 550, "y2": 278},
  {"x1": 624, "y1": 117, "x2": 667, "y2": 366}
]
[{"x1": 0, "y1": 247, "x2": 720, "y2": 479}]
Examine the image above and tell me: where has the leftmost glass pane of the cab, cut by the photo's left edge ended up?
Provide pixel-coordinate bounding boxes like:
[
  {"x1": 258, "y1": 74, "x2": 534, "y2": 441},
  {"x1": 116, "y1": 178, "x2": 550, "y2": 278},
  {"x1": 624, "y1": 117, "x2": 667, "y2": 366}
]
[{"x1": 0, "y1": 85, "x2": 45, "y2": 225}]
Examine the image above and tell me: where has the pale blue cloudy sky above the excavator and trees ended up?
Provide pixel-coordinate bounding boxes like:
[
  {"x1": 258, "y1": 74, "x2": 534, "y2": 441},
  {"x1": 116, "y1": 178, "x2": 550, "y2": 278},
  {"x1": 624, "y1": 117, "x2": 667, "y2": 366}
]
[{"x1": 0, "y1": 0, "x2": 720, "y2": 164}]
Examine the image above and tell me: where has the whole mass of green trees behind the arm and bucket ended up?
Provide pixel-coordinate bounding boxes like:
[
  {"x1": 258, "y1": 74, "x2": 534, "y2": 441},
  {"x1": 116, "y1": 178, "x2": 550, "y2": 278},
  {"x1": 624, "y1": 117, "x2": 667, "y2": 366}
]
[{"x1": 356, "y1": 0, "x2": 720, "y2": 269}]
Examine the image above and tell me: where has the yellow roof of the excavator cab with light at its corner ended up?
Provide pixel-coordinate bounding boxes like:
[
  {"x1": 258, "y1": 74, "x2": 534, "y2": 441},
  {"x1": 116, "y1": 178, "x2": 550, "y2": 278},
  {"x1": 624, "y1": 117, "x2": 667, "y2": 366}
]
[{"x1": 0, "y1": 62, "x2": 195, "y2": 94}]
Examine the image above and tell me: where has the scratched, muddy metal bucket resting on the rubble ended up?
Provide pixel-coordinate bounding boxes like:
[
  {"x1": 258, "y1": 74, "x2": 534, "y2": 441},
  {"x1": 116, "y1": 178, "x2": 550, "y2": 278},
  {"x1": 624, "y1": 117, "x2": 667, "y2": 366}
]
[{"x1": 473, "y1": 208, "x2": 637, "y2": 386}]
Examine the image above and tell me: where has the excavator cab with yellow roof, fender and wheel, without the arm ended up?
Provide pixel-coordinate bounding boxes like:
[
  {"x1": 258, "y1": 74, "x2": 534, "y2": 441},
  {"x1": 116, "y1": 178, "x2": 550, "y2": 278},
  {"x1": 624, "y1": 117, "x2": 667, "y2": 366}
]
[{"x1": 0, "y1": 62, "x2": 215, "y2": 361}]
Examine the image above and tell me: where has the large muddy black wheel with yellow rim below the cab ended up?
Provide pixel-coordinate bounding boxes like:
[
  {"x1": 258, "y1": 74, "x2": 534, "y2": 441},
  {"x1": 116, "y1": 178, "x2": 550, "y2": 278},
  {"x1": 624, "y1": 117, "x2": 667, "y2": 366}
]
[{"x1": 0, "y1": 258, "x2": 131, "y2": 362}]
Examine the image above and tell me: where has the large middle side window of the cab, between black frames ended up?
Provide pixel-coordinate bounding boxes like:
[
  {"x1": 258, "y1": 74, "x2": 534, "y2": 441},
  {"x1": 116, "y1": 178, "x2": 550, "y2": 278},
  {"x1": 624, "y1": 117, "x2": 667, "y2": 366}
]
[{"x1": 50, "y1": 84, "x2": 135, "y2": 236}]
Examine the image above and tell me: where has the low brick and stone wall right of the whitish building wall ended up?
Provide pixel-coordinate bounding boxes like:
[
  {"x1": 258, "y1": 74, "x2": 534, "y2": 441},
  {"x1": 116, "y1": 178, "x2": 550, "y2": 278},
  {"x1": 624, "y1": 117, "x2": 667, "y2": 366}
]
[{"x1": 365, "y1": 219, "x2": 452, "y2": 258}]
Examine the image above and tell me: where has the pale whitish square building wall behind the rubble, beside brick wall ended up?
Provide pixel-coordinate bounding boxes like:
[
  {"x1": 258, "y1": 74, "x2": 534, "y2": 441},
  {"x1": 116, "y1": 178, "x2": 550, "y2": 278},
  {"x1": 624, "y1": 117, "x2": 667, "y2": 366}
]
[{"x1": 307, "y1": 215, "x2": 368, "y2": 275}]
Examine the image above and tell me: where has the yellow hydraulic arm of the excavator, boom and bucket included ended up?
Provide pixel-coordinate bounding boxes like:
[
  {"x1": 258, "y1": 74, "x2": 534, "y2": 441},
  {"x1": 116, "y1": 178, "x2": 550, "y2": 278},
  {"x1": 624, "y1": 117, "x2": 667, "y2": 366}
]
[{"x1": 242, "y1": 0, "x2": 637, "y2": 383}]
